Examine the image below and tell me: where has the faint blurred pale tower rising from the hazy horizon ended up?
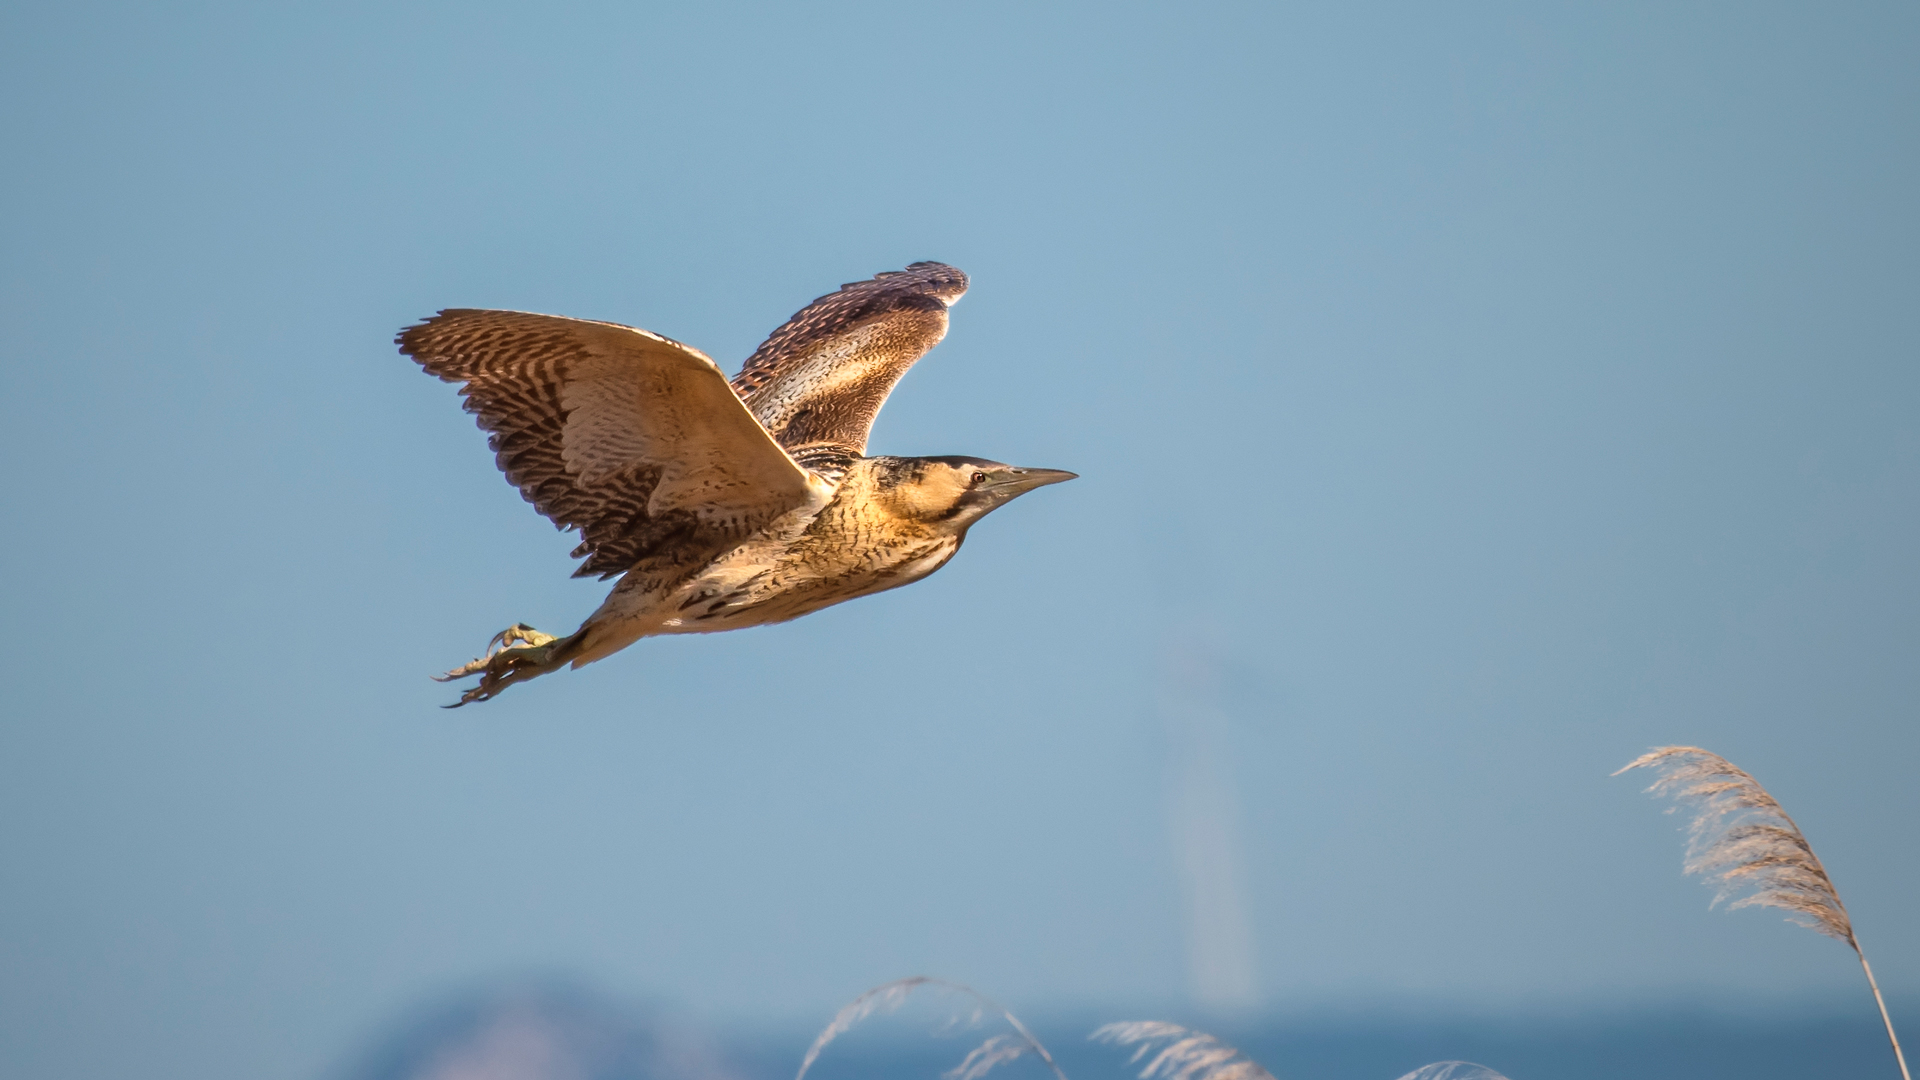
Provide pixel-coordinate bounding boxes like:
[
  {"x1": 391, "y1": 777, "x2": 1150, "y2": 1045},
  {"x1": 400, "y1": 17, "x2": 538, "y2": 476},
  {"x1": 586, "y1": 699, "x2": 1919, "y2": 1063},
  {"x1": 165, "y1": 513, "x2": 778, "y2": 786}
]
[{"x1": 1160, "y1": 640, "x2": 1260, "y2": 1011}]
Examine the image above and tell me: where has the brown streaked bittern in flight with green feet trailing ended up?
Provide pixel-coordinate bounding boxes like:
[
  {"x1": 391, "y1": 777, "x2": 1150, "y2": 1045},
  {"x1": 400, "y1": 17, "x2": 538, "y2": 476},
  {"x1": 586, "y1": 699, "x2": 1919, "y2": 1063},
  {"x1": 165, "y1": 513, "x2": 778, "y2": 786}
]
[{"x1": 396, "y1": 255, "x2": 1073, "y2": 707}]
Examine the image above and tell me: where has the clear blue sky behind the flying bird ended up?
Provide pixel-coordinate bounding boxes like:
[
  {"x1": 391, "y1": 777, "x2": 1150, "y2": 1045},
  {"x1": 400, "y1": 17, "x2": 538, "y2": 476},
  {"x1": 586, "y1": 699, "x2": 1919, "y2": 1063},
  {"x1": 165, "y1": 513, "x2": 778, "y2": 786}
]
[{"x1": 0, "y1": 4, "x2": 1920, "y2": 1078}]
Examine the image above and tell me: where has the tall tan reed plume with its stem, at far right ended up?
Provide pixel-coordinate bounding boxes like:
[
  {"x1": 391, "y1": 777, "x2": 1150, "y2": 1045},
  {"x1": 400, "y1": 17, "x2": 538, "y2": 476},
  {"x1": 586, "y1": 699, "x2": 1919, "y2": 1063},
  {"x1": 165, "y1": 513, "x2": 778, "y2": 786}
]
[{"x1": 1615, "y1": 746, "x2": 1912, "y2": 1080}]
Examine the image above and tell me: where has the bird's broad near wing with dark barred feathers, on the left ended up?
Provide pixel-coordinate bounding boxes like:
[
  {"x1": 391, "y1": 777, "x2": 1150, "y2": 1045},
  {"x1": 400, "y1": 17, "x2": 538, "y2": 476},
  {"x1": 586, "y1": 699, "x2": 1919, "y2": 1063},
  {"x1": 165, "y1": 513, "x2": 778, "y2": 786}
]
[{"x1": 396, "y1": 309, "x2": 822, "y2": 577}]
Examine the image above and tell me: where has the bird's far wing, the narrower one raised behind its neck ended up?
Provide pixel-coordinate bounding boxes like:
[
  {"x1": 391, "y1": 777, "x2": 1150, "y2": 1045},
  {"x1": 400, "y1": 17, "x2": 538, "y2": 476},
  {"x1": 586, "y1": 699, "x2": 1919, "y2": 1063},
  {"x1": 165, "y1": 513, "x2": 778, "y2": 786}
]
[{"x1": 733, "y1": 263, "x2": 968, "y2": 465}]
